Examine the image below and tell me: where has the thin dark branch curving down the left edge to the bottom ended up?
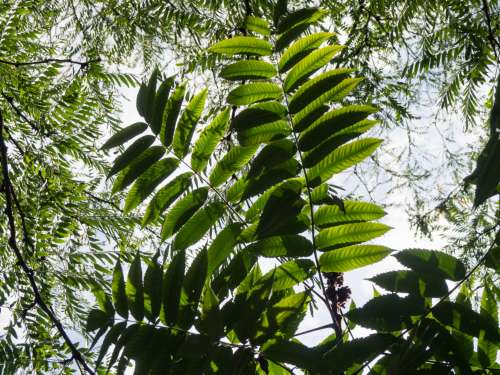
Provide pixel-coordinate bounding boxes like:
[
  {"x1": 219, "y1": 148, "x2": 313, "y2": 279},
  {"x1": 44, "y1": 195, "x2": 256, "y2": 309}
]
[{"x1": 0, "y1": 110, "x2": 94, "y2": 374}]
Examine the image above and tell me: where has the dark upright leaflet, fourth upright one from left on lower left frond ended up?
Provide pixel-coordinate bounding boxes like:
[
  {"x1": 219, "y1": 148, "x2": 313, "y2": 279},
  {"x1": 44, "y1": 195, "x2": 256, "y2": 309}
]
[{"x1": 160, "y1": 251, "x2": 186, "y2": 325}]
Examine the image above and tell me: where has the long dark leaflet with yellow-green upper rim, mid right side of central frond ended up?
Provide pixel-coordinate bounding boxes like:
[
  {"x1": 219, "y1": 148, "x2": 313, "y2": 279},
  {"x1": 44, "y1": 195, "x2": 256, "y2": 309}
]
[{"x1": 298, "y1": 105, "x2": 378, "y2": 151}]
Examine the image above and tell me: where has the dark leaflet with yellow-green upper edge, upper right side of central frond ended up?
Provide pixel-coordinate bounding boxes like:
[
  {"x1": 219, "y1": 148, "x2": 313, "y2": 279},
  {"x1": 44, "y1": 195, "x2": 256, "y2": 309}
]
[{"x1": 288, "y1": 68, "x2": 355, "y2": 114}]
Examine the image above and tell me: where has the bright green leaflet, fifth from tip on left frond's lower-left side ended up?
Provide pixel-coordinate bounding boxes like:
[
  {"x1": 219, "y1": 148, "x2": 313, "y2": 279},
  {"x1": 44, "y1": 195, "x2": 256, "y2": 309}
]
[{"x1": 142, "y1": 172, "x2": 193, "y2": 227}]
